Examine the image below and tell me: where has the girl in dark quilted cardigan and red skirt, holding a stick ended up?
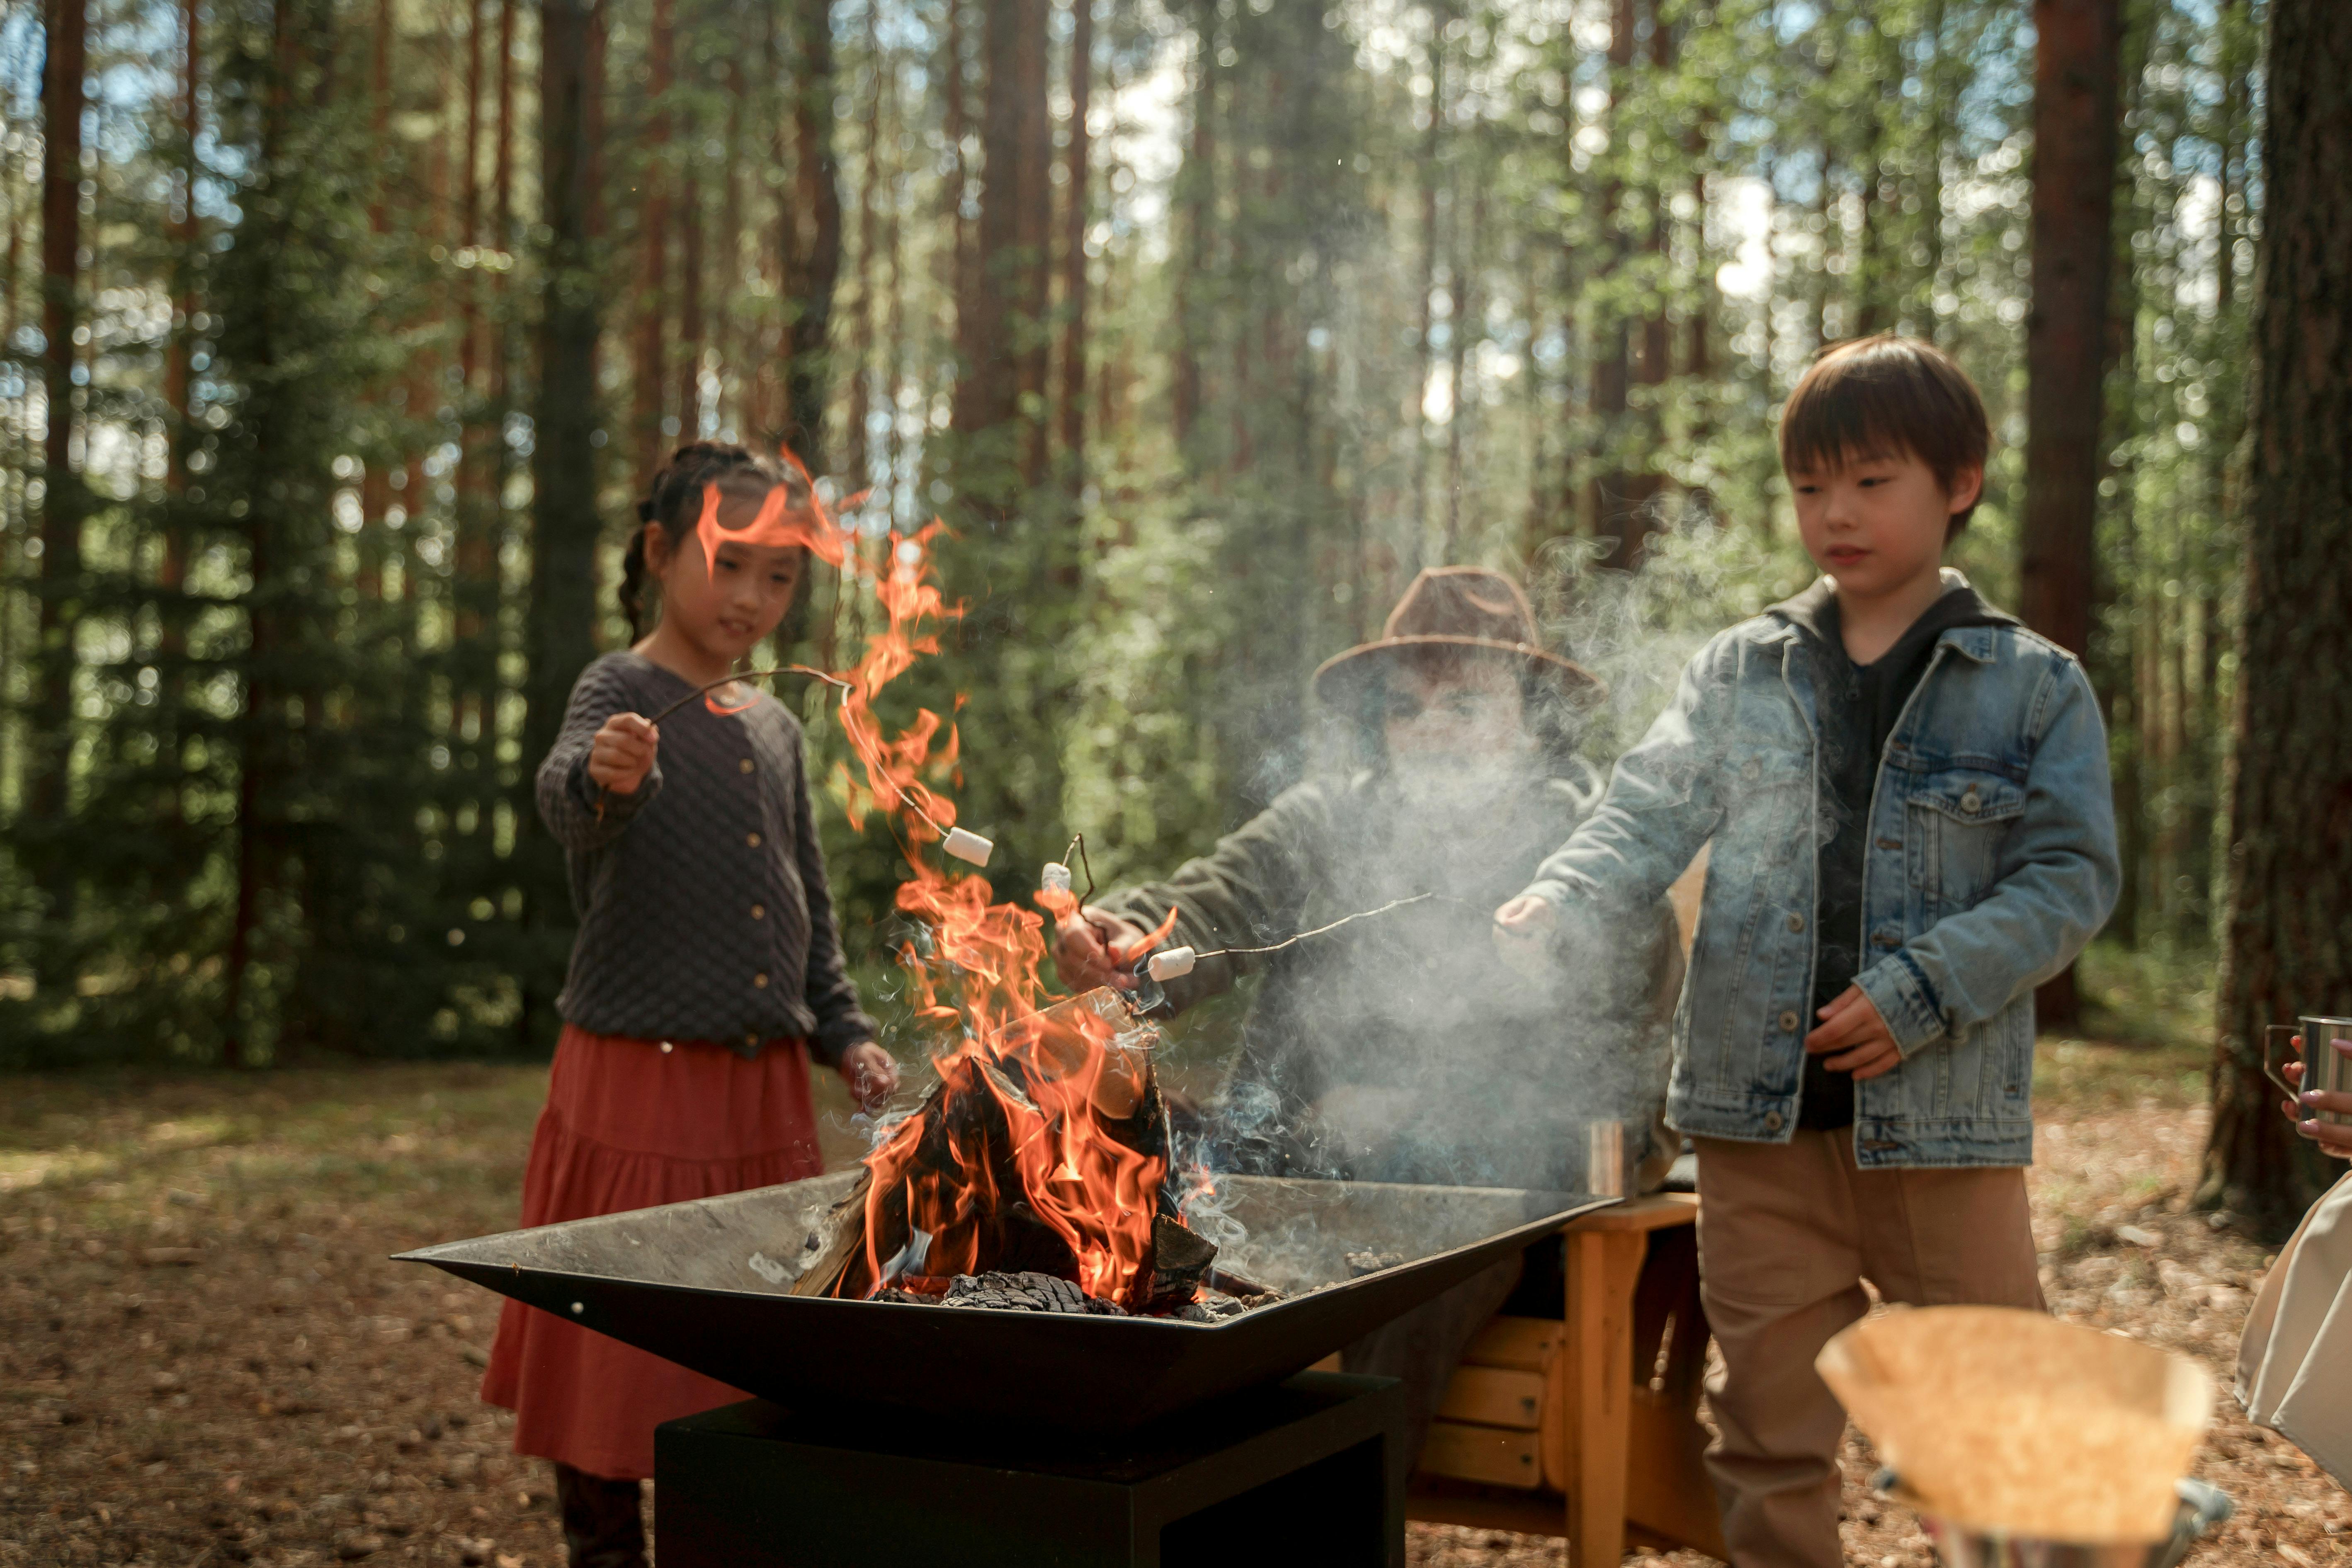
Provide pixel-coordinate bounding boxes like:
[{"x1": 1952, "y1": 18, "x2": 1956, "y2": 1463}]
[{"x1": 482, "y1": 442, "x2": 898, "y2": 1568}]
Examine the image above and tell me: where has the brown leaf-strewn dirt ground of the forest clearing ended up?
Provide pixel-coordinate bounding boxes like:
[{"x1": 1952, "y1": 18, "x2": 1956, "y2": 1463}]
[{"x1": 0, "y1": 1044, "x2": 2352, "y2": 1568}]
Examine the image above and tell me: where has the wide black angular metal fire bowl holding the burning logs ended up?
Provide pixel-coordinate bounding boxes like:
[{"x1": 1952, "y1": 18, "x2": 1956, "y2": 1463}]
[{"x1": 398, "y1": 1171, "x2": 1616, "y2": 1432}]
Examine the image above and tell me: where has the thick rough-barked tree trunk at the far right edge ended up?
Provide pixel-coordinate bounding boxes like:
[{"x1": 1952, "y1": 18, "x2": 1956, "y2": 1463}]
[{"x1": 2202, "y1": 0, "x2": 2352, "y2": 1237}]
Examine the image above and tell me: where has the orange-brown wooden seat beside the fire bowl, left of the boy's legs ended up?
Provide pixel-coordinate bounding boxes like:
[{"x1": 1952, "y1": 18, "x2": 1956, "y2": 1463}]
[{"x1": 1406, "y1": 1192, "x2": 1724, "y2": 1568}]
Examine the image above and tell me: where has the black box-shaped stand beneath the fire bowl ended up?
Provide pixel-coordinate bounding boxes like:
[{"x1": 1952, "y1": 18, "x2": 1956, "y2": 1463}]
[{"x1": 654, "y1": 1373, "x2": 1409, "y2": 1568}]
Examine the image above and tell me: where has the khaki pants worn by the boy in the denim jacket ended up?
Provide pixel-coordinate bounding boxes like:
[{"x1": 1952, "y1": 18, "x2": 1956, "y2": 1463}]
[{"x1": 1696, "y1": 1129, "x2": 2044, "y2": 1568}]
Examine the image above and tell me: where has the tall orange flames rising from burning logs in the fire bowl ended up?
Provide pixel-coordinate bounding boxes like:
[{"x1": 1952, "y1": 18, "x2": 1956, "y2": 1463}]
[{"x1": 813, "y1": 510, "x2": 1167, "y2": 1305}]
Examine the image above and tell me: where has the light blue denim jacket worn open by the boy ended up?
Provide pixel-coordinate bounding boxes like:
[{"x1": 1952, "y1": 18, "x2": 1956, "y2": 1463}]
[{"x1": 1527, "y1": 583, "x2": 2121, "y2": 1166}]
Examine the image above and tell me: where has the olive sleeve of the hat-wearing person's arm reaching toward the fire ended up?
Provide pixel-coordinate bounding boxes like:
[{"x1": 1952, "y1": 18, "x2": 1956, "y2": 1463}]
[{"x1": 1096, "y1": 783, "x2": 1334, "y2": 1013}]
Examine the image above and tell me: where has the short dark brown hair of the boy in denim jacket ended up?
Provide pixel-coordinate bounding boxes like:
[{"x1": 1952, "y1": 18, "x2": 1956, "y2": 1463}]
[{"x1": 1780, "y1": 331, "x2": 1992, "y2": 541}]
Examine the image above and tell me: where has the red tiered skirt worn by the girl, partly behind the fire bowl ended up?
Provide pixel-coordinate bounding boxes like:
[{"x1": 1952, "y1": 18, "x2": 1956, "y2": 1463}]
[{"x1": 482, "y1": 1025, "x2": 825, "y2": 1481}]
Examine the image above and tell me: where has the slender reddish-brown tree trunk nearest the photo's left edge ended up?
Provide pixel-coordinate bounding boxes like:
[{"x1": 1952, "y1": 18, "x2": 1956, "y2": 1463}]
[{"x1": 24, "y1": 0, "x2": 90, "y2": 990}]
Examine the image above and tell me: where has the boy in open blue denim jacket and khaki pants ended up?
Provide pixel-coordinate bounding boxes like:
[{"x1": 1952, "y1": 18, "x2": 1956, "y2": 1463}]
[{"x1": 1496, "y1": 336, "x2": 2119, "y2": 1568}]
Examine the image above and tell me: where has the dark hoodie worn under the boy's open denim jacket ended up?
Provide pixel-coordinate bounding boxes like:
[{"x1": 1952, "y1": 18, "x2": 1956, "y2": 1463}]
[{"x1": 1764, "y1": 569, "x2": 2018, "y2": 1131}]
